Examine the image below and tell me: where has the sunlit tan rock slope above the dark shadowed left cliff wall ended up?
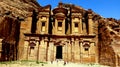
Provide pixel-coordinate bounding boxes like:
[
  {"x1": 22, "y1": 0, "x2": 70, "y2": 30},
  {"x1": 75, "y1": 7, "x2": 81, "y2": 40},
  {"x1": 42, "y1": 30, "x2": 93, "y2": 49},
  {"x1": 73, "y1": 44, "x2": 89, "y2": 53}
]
[{"x1": 0, "y1": 0, "x2": 40, "y2": 17}]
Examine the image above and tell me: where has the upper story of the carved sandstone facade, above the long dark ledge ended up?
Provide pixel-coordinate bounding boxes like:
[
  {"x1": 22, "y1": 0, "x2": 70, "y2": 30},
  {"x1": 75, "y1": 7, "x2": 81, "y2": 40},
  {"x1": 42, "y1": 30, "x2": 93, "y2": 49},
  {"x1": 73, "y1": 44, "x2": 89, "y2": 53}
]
[{"x1": 21, "y1": 3, "x2": 94, "y2": 35}]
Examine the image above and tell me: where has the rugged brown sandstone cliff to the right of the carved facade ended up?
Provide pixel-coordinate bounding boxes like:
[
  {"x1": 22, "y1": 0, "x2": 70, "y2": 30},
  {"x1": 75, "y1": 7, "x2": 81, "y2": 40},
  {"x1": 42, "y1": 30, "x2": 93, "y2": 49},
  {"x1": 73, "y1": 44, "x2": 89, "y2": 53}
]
[{"x1": 98, "y1": 18, "x2": 120, "y2": 66}]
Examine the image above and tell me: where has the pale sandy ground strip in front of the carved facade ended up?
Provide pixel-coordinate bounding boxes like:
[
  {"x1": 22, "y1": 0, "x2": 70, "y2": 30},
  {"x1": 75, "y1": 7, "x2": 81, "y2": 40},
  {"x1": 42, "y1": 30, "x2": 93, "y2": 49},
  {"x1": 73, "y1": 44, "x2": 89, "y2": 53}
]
[{"x1": 0, "y1": 61, "x2": 109, "y2": 67}]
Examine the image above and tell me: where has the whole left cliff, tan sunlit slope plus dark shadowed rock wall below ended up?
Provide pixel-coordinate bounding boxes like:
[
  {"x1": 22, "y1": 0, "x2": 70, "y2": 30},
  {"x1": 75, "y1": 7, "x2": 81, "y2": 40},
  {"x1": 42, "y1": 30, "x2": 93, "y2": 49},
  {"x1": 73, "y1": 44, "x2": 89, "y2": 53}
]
[{"x1": 0, "y1": 0, "x2": 40, "y2": 61}]
